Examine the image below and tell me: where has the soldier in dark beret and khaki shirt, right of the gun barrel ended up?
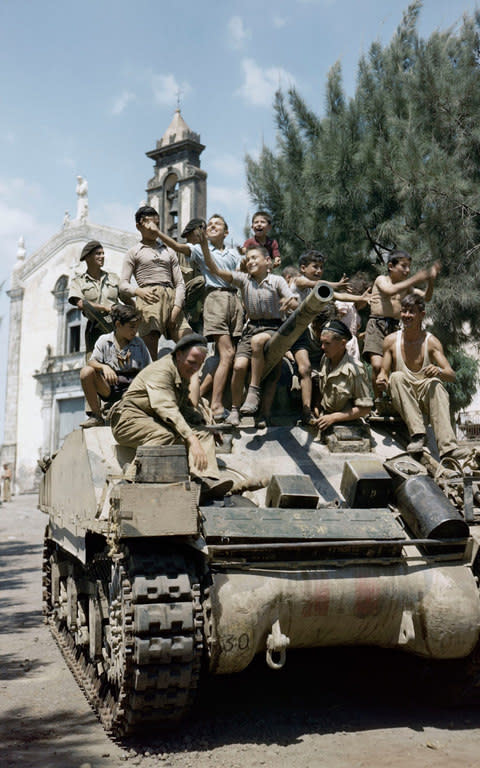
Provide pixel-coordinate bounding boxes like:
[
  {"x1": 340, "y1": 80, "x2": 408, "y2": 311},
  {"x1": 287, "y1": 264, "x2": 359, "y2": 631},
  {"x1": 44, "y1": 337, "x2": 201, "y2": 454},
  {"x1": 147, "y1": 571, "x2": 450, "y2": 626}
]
[{"x1": 314, "y1": 320, "x2": 373, "y2": 432}]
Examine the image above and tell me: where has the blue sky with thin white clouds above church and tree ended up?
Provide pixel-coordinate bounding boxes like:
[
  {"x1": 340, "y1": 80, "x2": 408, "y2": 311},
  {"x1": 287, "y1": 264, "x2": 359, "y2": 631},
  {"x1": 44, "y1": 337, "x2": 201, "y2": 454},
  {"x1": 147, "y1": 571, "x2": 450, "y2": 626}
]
[{"x1": 0, "y1": 0, "x2": 477, "y2": 440}]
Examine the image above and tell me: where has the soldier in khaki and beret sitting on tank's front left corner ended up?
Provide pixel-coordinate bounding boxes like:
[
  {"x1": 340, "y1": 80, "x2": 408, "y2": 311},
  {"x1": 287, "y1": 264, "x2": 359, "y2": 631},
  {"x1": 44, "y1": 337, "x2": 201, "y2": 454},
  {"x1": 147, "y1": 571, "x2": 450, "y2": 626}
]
[{"x1": 110, "y1": 333, "x2": 233, "y2": 497}]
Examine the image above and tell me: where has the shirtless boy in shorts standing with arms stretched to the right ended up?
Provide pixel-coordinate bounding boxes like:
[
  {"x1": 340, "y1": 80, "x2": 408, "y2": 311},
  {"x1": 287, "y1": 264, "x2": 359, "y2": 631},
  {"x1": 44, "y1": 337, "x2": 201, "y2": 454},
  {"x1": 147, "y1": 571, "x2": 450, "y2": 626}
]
[{"x1": 363, "y1": 250, "x2": 440, "y2": 398}]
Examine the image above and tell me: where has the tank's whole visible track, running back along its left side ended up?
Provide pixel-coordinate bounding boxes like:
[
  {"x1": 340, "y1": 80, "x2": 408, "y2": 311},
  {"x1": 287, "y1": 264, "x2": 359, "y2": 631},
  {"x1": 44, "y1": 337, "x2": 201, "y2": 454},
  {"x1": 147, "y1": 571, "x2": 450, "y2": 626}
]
[{"x1": 43, "y1": 540, "x2": 203, "y2": 736}]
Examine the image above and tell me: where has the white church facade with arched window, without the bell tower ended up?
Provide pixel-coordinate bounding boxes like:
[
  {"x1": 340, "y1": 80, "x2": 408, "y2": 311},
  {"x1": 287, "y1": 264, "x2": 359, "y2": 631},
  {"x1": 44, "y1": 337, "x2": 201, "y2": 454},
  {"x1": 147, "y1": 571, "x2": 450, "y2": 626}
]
[{"x1": 2, "y1": 221, "x2": 137, "y2": 493}]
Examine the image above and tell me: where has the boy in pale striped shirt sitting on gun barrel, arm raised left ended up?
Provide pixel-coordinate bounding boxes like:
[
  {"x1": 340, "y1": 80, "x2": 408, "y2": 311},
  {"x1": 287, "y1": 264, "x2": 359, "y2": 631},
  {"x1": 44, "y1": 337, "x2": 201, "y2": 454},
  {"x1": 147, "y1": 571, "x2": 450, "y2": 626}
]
[{"x1": 198, "y1": 239, "x2": 298, "y2": 426}]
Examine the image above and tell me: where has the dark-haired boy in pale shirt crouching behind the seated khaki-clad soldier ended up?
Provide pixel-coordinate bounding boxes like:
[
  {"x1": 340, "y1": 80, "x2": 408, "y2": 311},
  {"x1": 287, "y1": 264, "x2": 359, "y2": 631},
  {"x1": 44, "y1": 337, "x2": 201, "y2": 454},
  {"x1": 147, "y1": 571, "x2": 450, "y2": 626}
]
[{"x1": 80, "y1": 304, "x2": 152, "y2": 429}]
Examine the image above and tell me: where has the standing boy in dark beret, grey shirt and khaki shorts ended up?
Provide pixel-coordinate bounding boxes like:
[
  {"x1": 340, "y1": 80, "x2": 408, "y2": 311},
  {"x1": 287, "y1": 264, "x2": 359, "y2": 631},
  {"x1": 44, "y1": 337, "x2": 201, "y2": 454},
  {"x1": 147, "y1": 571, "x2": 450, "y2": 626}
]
[{"x1": 120, "y1": 205, "x2": 192, "y2": 360}]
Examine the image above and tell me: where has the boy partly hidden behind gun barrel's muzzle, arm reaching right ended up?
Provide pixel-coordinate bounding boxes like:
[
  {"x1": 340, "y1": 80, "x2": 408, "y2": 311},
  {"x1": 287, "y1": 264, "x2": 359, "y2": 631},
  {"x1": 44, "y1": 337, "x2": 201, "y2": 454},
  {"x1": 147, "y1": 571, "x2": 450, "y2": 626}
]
[{"x1": 291, "y1": 250, "x2": 351, "y2": 425}]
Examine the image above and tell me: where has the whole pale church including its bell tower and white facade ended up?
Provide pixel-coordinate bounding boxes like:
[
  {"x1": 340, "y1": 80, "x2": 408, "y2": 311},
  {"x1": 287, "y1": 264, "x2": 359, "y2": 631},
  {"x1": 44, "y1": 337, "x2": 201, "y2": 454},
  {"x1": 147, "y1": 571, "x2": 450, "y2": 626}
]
[{"x1": 1, "y1": 110, "x2": 207, "y2": 493}]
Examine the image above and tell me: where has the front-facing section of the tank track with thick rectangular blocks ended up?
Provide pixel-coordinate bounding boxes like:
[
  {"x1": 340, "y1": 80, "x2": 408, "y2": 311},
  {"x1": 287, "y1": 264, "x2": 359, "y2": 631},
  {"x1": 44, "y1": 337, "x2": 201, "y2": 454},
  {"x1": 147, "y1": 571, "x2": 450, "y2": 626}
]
[{"x1": 102, "y1": 552, "x2": 203, "y2": 735}]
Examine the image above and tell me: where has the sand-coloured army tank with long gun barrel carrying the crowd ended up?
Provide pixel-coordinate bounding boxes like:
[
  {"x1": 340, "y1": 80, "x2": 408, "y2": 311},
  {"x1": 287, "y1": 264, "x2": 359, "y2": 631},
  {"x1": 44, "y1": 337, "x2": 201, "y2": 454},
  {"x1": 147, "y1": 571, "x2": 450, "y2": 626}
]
[{"x1": 39, "y1": 285, "x2": 480, "y2": 736}]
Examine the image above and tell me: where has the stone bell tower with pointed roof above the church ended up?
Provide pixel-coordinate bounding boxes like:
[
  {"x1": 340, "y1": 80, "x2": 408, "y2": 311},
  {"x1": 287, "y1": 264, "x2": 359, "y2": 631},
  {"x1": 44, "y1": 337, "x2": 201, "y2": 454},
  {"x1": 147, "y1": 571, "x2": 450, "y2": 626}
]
[{"x1": 146, "y1": 109, "x2": 207, "y2": 239}]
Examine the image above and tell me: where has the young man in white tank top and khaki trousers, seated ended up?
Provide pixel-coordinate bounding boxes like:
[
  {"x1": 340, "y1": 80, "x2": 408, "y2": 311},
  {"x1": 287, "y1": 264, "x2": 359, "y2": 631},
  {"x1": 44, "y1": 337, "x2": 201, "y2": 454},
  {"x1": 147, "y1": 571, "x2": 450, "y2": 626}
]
[{"x1": 377, "y1": 294, "x2": 469, "y2": 459}]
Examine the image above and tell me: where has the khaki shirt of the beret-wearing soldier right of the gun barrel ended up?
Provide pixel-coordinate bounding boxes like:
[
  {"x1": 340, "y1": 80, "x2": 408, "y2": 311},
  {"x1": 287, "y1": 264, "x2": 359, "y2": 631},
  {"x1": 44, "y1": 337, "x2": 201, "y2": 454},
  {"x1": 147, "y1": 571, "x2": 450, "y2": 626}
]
[{"x1": 319, "y1": 353, "x2": 373, "y2": 413}]
